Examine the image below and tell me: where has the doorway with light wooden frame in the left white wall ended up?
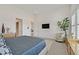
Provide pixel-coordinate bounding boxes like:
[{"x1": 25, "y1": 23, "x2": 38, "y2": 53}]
[{"x1": 16, "y1": 18, "x2": 22, "y2": 36}]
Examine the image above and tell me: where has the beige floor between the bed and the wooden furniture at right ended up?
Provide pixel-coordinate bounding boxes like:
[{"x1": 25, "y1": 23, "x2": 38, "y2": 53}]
[{"x1": 47, "y1": 40, "x2": 68, "y2": 55}]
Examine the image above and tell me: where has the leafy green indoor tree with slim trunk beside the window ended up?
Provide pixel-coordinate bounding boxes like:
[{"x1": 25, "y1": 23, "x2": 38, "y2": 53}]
[{"x1": 57, "y1": 17, "x2": 70, "y2": 41}]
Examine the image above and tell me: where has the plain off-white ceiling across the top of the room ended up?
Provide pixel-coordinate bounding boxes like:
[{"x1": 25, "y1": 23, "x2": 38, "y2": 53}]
[{"x1": 0, "y1": 4, "x2": 69, "y2": 14}]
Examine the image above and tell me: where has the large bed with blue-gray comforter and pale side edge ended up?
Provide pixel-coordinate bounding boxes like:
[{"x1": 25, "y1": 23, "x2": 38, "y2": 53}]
[{"x1": 2, "y1": 36, "x2": 52, "y2": 55}]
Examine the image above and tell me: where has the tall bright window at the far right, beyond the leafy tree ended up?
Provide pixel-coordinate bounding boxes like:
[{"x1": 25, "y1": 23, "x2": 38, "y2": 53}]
[{"x1": 71, "y1": 9, "x2": 79, "y2": 39}]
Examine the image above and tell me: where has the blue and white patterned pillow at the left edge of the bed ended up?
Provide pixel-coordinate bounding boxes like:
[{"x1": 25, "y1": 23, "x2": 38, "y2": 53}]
[{"x1": 0, "y1": 38, "x2": 12, "y2": 55}]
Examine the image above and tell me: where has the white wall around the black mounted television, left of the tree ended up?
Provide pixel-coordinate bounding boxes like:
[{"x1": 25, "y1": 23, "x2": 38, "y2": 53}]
[{"x1": 34, "y1": 5, "x2": 70, "y2": 38}]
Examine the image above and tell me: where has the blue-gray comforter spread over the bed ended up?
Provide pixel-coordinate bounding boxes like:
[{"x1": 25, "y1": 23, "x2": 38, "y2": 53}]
[{"x1": 5, "y1": 36, "x2": 46, "y2": 55}]
